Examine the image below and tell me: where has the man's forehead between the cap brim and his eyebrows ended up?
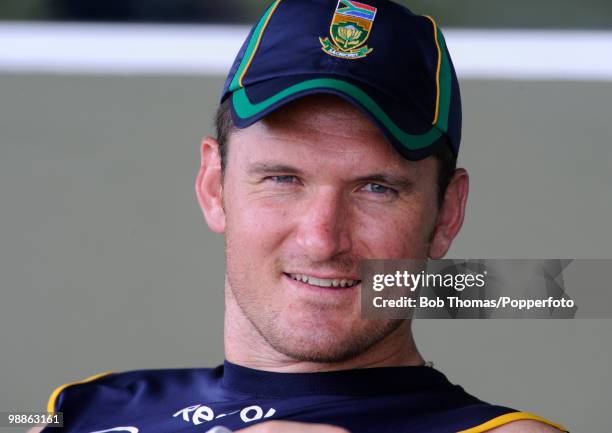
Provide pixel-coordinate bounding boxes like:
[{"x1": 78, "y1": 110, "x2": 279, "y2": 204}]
[{"x1": 229, "y1": 94, "x2": 429, "y2": 173}]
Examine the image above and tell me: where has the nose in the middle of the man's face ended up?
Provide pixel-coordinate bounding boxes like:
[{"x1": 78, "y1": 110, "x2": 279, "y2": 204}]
[{"x1": 297, "y1": 186, "x2": 352, "y2": 262}]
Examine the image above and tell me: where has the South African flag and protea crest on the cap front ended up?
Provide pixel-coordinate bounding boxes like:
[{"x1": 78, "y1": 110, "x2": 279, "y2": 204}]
[{"x1": 319, "y1": 0, "x2": 376, "y2": 59}]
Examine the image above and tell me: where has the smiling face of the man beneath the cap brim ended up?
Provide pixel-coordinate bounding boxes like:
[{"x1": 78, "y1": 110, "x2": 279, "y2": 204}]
[{"x1": 201, "y1": 96, "x2": 464, "y2": 362}]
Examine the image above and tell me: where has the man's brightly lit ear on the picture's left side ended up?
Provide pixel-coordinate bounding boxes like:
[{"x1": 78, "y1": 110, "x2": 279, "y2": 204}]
[{"x1": 195, "y1": 137, "x2": 225, "y2": 233}]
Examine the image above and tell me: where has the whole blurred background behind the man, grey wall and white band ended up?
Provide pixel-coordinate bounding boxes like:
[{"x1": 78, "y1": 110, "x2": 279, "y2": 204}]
[{"x1": 0, "y1": 0, "x2": 612, "y2": 433}]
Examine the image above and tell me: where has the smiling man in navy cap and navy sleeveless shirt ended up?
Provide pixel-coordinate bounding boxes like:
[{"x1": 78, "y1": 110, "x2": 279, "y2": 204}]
[{"x1": 39, "y1": 0, "x2": 565, "y2": 433}]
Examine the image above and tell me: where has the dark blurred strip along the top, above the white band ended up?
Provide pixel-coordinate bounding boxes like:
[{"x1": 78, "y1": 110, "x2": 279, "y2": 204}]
[{"x1": 0, "y1": 0, "x2": 612, "y2": 29}]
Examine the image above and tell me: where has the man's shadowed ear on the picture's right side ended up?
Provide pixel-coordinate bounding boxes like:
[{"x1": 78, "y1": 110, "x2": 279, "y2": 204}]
[{"x1": 429, "y1": 168, "x2": 469, "y2": 259}]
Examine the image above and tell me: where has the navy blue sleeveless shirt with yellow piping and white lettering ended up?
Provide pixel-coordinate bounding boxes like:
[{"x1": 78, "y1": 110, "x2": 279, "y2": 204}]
[{"x1": 44, "y1": 361, "x2": 559, "y2": 433}]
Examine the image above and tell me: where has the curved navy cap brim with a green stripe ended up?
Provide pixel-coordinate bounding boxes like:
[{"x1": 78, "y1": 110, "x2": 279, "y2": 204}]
[{"x1": 231, "y1": 76, "x2": 449, "y2": 161}]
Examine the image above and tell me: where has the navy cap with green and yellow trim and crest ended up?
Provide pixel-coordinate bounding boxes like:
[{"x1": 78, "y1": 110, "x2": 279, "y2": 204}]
[{"x1": 221, "y1": 0, "x2": 461, "y2": 160}]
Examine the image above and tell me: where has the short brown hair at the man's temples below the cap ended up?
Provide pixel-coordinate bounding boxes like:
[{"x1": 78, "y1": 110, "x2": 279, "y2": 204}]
[{"x1": 215, "y1": 99, "x2": 457, "y2": 206}]
